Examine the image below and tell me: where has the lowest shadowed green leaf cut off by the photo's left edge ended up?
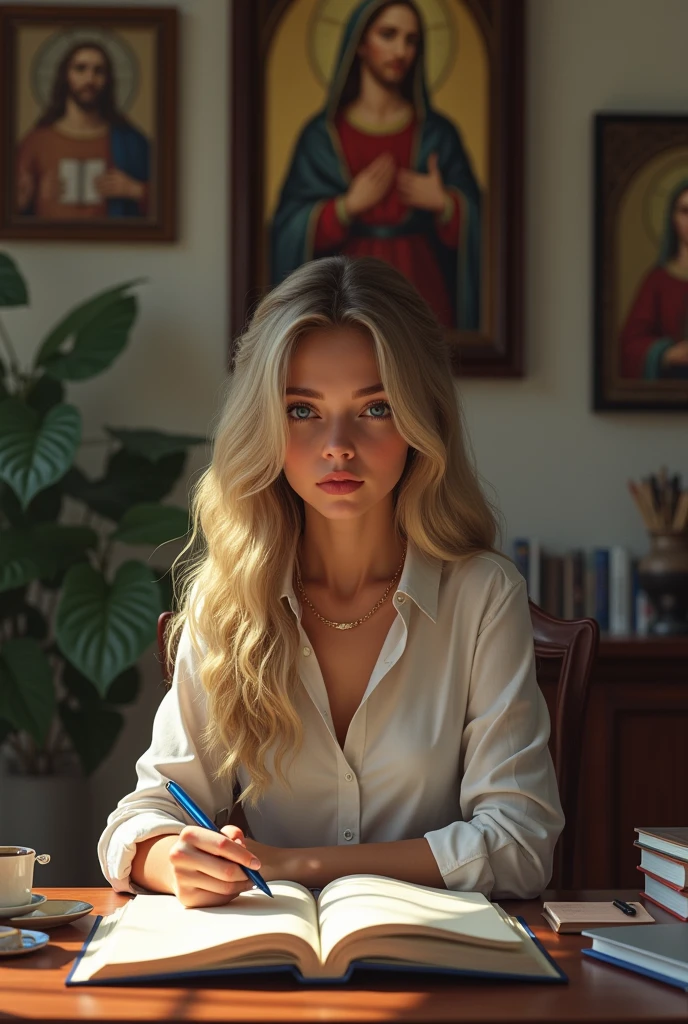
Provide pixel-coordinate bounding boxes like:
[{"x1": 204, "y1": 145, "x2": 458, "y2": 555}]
[{"x1": 0, "y1": 637, "x2": 55, "y2": 745}]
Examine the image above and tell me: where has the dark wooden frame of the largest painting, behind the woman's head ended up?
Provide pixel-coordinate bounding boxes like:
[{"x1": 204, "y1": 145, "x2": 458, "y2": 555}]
[{"x1": 229, "y1": 0, "x2": 524, "y2": 377}]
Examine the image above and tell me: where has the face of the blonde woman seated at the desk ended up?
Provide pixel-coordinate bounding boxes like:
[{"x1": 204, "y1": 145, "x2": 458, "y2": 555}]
[{"x1": 284, "y1": 328, "x2": 409, "y2": 519}]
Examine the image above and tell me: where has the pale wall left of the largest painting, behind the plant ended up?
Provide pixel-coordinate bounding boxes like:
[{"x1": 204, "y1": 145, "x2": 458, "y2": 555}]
[{"x1": 0, "y1": 0, "x2": 228, "y2": 885}]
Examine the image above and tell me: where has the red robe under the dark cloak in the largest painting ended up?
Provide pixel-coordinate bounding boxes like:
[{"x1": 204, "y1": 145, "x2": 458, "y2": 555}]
[{"x1": 314, "y1": 112, "x2": 460, "y2": 327}]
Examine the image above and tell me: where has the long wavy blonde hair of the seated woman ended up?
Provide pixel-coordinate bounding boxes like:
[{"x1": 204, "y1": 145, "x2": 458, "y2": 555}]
[{"x1": 167, "y1": 256, "x2": 500, "y2": 806}]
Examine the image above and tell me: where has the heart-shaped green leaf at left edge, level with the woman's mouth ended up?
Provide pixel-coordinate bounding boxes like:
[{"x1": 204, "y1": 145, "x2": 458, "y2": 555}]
[{"x1": 0, "y1": 398, "x2": 81, "y2": 509}]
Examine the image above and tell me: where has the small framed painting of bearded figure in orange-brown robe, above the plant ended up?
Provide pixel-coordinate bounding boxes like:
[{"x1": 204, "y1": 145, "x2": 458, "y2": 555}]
[{"x1": 0, "y1": 4, "x2": 177, "y2": 242}]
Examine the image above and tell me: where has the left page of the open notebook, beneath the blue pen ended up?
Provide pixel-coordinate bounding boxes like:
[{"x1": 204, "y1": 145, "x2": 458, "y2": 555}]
[{"x1": 74, "y1": 882, "x2": 319, "y2": 981}]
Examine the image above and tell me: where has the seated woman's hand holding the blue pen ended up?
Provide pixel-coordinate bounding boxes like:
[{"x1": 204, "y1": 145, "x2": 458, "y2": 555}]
[{"x1": 169, "y1": 825, "x2": 260, "y2": 907}]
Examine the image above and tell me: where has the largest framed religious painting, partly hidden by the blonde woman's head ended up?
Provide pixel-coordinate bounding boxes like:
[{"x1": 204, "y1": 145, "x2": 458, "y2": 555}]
[{"x1": 232, "y1": 0, "x2": 522, "y2": 376}]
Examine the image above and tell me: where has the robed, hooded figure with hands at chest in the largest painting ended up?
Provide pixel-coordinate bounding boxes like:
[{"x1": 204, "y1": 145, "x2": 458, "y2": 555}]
[{"x1": 271, "y1": 0, "x2": 480, "y2": 331}]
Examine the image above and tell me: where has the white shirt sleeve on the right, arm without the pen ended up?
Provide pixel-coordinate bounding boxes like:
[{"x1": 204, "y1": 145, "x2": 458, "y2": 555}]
[{"x1": 425, "y1": 579, "x2": 564, "y2": 899}]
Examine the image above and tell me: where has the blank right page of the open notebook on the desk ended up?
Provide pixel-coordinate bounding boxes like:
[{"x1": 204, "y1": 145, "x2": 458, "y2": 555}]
[{"x1": 317, "y1": 874, "x2": 521, "y2": 963}]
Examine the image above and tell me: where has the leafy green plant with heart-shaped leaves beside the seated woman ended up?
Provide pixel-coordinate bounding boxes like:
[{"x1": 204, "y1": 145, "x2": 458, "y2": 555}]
[{"x1": 0, "y1": 253, "x2": 206, "y2": 884}]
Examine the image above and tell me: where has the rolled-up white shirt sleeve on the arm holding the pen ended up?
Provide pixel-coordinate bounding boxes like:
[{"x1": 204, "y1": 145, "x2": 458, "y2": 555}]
[{"x1": 98, "y1": 625, "x2": 226, "y2": 893}]
